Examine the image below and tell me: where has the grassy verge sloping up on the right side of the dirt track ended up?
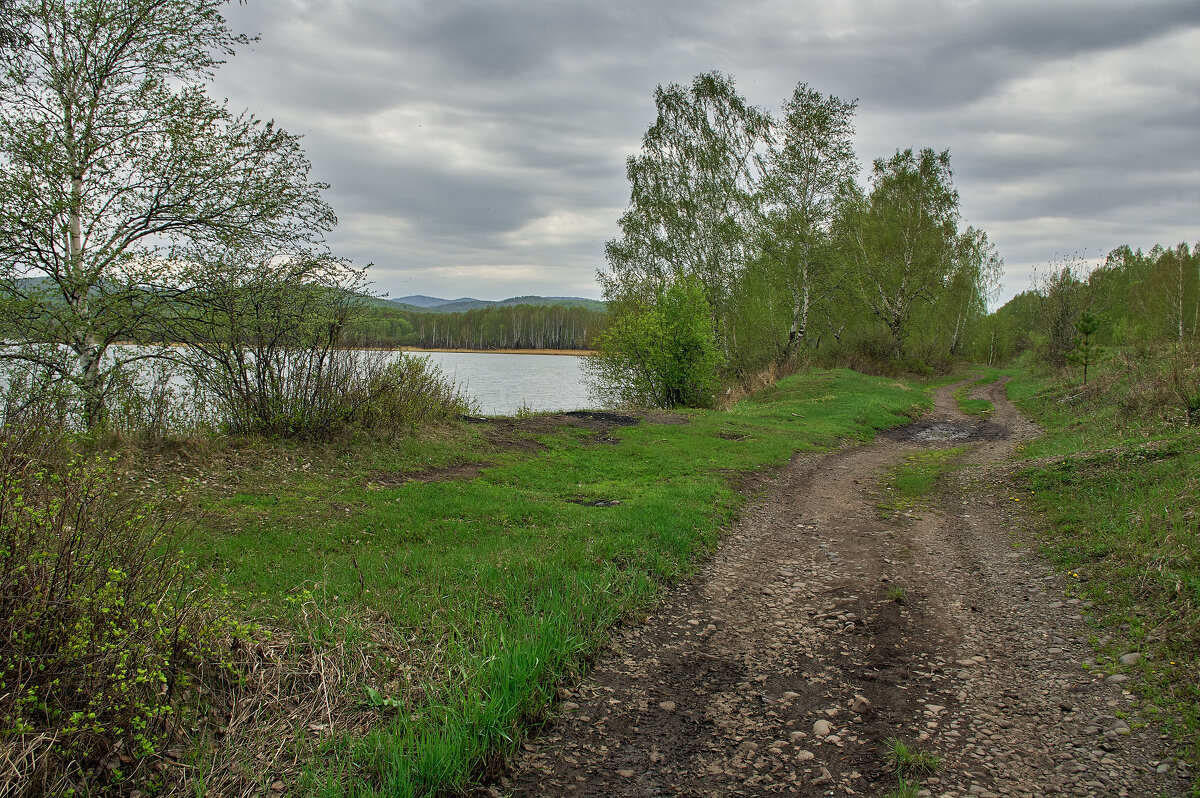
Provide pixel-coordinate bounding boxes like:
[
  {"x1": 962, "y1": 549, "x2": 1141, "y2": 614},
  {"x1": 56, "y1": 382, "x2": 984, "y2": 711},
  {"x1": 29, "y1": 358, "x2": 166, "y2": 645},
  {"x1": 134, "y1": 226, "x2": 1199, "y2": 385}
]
[{"x1": 1008, "y1": 359, "x2": 1200, "y2": 796}]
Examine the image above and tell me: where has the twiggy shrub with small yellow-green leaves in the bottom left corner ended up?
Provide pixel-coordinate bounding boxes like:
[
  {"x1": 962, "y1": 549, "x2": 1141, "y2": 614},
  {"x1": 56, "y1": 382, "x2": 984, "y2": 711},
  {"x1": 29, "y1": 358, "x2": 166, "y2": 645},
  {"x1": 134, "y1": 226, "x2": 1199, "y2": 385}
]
[{"x1": 0, "y1": 413, "x2": 244, "y2": 796}]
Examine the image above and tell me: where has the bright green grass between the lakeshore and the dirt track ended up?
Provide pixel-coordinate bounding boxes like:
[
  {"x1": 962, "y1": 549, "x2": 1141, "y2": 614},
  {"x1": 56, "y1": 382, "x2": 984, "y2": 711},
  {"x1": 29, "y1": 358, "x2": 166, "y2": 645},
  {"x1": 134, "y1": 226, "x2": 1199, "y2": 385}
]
[{"x1": 175, "y1": 370, "x2": 929, "y2": 796}]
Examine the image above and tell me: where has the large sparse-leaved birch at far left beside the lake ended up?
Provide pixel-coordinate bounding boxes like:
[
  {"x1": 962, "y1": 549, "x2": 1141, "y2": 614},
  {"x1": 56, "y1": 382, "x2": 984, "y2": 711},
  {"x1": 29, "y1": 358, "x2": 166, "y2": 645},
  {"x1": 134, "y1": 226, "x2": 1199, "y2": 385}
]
[{"x1": 0, "y1": 0, "x2": 335, "y2": 426}]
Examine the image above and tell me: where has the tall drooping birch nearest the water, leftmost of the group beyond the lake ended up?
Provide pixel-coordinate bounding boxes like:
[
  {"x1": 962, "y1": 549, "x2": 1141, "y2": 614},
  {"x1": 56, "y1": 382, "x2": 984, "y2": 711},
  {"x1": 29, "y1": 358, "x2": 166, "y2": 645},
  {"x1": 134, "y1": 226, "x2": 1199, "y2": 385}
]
[{"x1": 593, "y1": 72, "x2": 772, "y2": 406}]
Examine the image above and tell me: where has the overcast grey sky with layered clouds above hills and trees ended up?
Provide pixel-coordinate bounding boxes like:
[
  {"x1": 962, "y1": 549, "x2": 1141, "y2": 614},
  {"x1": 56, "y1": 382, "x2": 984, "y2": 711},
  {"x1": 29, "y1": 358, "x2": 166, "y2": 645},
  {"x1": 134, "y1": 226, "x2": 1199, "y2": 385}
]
[{"x1": 211, "y1": 0, "x2": 1200, "y2": 301}]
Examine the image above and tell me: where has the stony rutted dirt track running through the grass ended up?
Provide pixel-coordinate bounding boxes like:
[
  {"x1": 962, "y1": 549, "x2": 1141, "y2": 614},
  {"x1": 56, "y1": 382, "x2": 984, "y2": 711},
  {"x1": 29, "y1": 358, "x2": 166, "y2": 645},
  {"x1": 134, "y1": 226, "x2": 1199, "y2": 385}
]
[{"x1": 486, "y1": 384, "x2": 1187, "y2": 798}]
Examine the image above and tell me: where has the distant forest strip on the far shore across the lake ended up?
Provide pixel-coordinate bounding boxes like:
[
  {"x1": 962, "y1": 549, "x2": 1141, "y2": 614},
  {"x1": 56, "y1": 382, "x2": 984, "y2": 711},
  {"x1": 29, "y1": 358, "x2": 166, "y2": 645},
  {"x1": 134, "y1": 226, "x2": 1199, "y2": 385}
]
[{"x1": 348, "y1": 298, "x2": 605, "y2": 350}]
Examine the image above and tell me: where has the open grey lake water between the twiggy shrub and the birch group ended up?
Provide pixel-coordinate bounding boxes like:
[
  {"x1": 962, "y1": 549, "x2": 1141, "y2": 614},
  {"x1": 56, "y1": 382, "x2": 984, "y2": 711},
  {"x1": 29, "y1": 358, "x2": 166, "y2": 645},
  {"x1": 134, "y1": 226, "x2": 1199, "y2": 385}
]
[{"x1": 409, "y1": 352, "x2": 594, "y2": 415}]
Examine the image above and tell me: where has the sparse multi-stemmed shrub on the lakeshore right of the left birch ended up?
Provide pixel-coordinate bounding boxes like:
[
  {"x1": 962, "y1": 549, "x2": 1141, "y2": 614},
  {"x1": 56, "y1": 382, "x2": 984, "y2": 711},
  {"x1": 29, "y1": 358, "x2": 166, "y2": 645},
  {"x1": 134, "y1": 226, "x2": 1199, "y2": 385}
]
[{"x1": 175, "y1": 251, "x2": 469, "y2": 439}]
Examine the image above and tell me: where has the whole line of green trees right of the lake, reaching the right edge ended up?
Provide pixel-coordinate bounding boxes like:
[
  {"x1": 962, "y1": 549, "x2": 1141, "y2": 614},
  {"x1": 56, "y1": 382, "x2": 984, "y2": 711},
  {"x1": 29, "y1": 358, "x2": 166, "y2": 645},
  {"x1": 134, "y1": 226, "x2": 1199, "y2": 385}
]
[{"x1": 592, "y1": 72, "x2": 1200, "y2": 407}]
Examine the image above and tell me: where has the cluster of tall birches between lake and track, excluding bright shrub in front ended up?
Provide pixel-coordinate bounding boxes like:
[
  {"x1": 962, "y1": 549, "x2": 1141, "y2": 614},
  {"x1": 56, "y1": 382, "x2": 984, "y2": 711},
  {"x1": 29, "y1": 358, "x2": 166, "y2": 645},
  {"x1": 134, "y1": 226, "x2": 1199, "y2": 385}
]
[{"x1": 598, "y1": 72, "x2": 1001, "y2": 401}]
